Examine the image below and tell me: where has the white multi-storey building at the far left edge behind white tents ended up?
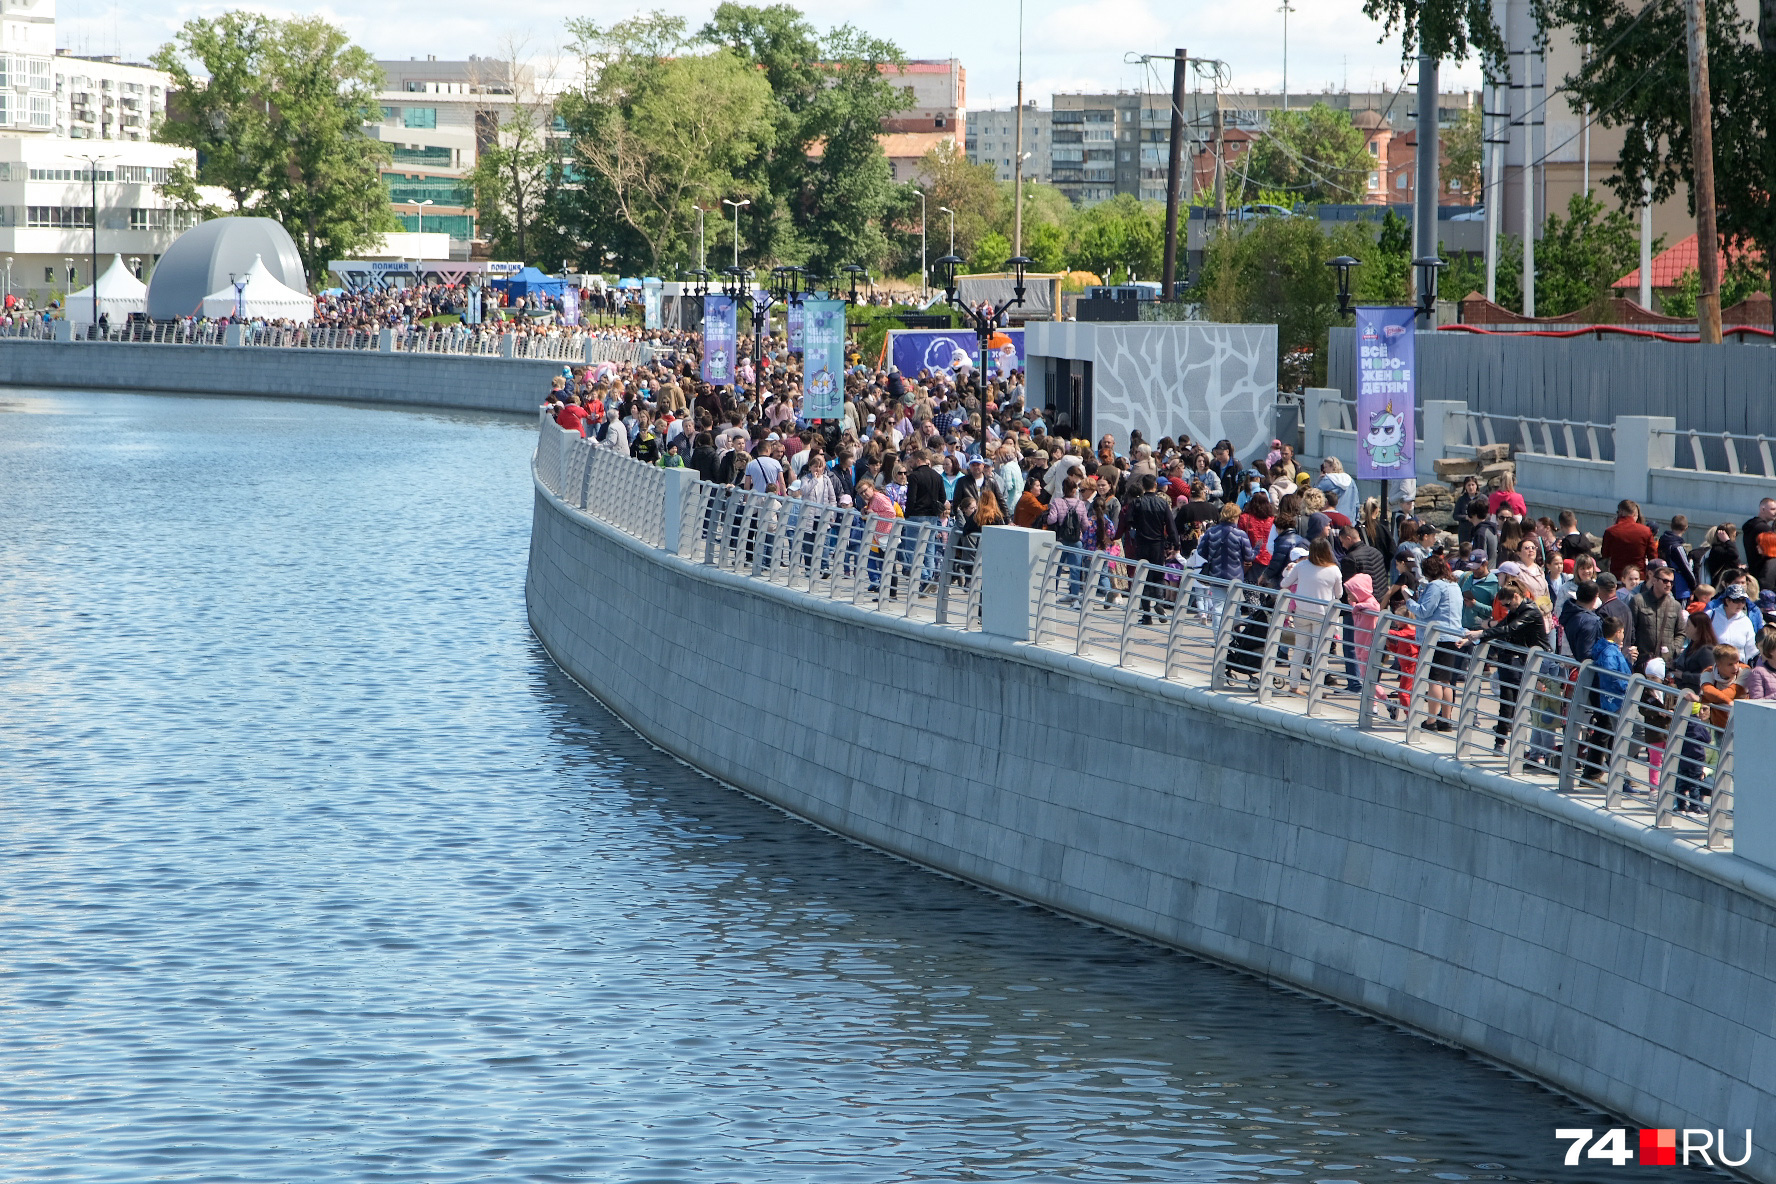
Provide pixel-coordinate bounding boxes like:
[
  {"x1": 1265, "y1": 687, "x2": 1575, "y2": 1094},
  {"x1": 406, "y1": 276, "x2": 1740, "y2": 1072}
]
[{"x1": 0, "y1": 0, "x2": 195, "y2": 307}]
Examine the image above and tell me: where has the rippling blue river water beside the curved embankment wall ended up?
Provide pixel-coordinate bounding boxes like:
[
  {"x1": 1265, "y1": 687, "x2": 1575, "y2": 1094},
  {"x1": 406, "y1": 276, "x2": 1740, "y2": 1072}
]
[{"x1": 0, "y1": 391, "x2": 1690, "y2": 1184}]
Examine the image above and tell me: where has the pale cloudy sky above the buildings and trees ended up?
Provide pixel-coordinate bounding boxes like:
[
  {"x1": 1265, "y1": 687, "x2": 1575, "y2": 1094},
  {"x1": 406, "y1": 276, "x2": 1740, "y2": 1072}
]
[{"x1": 57, "y1": 0, "x2": 1479, "y2": 110}]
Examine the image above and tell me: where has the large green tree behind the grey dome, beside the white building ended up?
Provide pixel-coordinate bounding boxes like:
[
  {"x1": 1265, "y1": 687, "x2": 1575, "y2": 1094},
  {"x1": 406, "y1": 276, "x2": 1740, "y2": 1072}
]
[{"x1": 155, "y1": 12, "x2": 400, "y2": 277}]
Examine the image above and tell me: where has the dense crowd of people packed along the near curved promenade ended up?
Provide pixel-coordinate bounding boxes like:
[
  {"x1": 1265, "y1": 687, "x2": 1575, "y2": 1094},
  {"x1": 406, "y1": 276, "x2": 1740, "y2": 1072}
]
[{"x1": 547, "y1": 334, "x2": 1776, "y2": 816}]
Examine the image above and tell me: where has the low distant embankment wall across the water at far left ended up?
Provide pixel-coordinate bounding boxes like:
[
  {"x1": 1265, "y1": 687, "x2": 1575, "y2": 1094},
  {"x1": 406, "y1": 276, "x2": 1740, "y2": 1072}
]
[{"x1": 0, "y1": 337, "x2": 561, "y2": 415}]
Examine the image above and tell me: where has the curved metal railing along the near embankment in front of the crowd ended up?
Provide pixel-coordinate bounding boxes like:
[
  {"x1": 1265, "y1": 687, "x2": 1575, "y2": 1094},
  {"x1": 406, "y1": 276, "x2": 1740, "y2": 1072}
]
[{"x1": 536, "y1": 417, "x2": 1733, "y2": 849}]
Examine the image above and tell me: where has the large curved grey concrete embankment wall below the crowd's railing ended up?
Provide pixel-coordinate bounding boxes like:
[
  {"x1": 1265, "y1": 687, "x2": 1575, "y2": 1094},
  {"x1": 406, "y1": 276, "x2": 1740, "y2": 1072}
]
[{"x1": 527, "y1": 485, "x2": 1776, "y2": 1180}]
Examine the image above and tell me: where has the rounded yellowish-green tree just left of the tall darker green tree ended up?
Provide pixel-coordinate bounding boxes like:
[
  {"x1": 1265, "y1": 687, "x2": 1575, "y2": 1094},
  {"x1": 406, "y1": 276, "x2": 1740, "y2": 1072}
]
[{"x1": 559, "y1": 14, "x2": 773, "y2": 272}]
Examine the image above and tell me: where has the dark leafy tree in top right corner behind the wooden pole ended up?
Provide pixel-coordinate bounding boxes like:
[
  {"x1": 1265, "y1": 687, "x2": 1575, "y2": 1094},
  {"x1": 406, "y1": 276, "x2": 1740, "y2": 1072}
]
[{"x1": 1536, "y1": 0, "x2": 1776, "y2": 309}]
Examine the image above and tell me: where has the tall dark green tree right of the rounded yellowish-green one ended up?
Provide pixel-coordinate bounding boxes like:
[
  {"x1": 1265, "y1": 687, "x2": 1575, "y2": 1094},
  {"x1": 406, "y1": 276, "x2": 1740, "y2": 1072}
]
[{"x1": 698, "y1": 2, "x2": 908, "y2": 270}]
